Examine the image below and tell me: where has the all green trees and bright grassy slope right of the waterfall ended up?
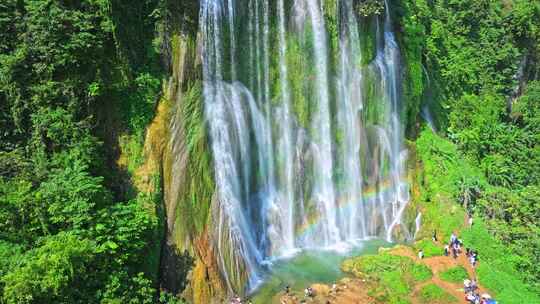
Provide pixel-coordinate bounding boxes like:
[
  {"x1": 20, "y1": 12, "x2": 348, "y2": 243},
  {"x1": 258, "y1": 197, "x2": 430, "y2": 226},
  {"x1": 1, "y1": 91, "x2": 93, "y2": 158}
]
[{"x1": 395, "y1": 0, "x2": 540, "y2": 303}]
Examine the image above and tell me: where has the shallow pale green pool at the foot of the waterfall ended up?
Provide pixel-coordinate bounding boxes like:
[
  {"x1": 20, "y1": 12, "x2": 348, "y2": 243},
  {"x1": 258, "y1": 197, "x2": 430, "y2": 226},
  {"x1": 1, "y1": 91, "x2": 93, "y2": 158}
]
[{"x1": 252, "y1": 239, "x2": 391, "y2": 304}]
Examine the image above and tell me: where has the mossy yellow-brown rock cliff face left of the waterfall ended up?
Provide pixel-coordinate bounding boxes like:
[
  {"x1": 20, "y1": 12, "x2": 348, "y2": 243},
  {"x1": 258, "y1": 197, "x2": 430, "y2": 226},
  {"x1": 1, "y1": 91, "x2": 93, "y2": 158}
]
[{"x1": 136, "y1": 0, "x2": 226, "y2": 303}]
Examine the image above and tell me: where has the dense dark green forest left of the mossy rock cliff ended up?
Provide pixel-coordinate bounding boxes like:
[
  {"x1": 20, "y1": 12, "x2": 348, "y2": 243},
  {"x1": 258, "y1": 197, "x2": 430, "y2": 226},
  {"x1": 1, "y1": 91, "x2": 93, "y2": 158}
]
[{"x1": 0, "y1": 0, "x2": 189, "y2": 304}]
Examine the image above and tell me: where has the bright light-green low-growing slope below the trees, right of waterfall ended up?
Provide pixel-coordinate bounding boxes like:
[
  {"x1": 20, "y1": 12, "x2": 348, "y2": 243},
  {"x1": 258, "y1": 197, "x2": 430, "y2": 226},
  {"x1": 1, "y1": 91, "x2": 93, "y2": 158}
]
[{"x1": 417, "y1": 130, "x2": 540, "y2": 303}]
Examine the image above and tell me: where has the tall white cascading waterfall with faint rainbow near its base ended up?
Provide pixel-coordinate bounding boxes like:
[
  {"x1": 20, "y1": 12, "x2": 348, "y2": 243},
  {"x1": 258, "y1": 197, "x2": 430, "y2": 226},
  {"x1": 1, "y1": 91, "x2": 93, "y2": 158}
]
[{"x1": 200, "y1": 0, "x2": 409, "y2": 289}]
